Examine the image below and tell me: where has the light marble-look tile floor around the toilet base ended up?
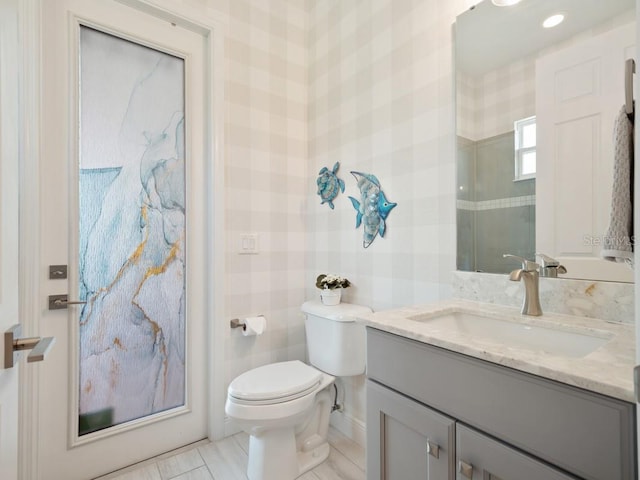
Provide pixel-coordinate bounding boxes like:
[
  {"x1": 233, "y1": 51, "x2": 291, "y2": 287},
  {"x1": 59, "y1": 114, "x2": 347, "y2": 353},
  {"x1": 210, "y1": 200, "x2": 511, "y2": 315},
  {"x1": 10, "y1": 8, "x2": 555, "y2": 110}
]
[{"x1": 95, "y1": 428, "x2": 365, "y2": 480}]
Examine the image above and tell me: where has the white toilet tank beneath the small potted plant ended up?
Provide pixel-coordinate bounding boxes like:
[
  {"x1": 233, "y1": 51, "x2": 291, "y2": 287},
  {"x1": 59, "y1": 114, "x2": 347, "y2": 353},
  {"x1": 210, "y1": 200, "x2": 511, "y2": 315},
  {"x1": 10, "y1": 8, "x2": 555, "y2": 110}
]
[{"x1": 302, "y1": 300, "x2": 371, "y2": 377}]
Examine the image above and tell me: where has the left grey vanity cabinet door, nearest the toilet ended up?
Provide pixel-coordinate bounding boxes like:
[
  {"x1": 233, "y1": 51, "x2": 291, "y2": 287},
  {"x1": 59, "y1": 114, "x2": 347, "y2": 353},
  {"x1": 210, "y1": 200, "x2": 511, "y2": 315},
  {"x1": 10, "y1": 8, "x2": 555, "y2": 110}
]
[{"x1": 366, "y1": 380, "x2": 455, "y2": 480}]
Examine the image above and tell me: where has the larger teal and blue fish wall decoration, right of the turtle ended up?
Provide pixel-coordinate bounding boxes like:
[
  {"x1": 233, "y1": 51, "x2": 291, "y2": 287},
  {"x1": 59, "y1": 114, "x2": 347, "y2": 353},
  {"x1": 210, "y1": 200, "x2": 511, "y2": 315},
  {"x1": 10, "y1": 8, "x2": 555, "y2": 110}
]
[{"x1": 349, "y1": 172, "x2": 398, "y2": 248}]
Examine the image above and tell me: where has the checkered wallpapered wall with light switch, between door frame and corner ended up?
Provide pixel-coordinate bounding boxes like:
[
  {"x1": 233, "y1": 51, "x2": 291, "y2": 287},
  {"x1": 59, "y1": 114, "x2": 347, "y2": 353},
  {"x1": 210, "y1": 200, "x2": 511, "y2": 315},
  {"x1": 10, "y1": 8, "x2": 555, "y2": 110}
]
[{"x1": 218, "y1": 0, "x2": 308, "y2": 394}]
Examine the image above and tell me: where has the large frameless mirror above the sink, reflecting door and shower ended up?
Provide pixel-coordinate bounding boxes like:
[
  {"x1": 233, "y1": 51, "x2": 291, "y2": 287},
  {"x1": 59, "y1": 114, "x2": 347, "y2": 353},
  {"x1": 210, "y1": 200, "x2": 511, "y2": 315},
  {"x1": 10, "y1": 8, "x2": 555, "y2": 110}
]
[{"x1": 455, "y1": 0, "x2": 635, "y2": 282}]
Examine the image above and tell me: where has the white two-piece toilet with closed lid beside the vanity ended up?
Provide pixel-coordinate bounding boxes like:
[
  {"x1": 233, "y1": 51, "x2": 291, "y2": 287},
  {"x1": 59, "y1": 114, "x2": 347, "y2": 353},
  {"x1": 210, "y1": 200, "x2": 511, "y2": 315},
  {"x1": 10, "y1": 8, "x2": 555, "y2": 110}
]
[{"x1": 225, "y1": 301, "x2": 371, "y2": 480}]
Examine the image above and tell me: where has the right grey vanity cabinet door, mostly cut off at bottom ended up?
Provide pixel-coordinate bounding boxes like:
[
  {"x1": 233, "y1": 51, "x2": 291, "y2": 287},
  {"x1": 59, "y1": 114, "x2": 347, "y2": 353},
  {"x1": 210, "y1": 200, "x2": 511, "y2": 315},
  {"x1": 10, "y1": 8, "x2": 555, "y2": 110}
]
[{"x1": 456, "y1": 423, "x2": 577, "y2": 480}]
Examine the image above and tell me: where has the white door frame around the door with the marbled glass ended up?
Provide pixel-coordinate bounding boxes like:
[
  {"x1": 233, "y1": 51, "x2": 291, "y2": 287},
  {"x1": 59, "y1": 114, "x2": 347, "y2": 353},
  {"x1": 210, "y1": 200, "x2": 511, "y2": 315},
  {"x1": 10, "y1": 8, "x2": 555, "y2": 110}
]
[{"x1": 18, "y1": 0, "x2": 227, "y2": 480}]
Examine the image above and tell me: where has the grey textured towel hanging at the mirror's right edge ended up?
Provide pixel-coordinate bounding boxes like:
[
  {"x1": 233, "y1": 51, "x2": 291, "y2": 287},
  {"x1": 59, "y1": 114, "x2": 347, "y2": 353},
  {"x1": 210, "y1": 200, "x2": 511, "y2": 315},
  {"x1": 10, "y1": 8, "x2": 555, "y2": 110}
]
[{"x1": 600, "y1": 106, "x2": 633, "y2": 268}]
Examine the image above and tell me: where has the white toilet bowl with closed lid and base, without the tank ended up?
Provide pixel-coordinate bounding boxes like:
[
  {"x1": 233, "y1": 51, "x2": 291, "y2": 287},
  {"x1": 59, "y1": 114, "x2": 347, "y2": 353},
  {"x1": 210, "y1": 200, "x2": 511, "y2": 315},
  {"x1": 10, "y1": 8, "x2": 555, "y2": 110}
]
[{"x1": 225, "y1": 360, "x2": 334, "y2": 480}]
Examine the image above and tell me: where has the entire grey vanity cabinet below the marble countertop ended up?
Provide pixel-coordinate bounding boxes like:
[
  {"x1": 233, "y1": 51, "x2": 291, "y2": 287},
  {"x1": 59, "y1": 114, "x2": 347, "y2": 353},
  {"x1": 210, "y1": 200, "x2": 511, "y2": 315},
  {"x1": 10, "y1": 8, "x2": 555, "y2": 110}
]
[{"x1": 367, "y1": 327, "x2": 637, "y2": 480}]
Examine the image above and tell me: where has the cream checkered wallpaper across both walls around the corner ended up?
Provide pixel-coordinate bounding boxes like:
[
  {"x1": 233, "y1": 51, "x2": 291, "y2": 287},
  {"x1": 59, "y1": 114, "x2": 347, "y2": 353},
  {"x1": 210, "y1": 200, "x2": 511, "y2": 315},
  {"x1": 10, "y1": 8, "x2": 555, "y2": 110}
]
[{"x1": 168, "y1": 0, "x2": 636, "y2": 442}]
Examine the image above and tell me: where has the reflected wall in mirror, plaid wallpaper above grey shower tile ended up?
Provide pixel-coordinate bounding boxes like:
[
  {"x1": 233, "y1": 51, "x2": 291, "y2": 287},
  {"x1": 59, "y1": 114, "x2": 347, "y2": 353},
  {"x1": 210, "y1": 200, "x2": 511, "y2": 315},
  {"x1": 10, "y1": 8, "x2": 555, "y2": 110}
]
[{"x1": 456, "y1": 50, "x2": 535, "y2": 273}]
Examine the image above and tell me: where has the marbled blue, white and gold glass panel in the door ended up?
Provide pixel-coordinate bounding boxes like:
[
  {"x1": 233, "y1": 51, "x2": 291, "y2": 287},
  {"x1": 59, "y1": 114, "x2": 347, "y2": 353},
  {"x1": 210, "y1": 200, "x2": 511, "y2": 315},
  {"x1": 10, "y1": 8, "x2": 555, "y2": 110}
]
[{"x1": 79, "y1": 27, "x2": 186, "y2": 435}]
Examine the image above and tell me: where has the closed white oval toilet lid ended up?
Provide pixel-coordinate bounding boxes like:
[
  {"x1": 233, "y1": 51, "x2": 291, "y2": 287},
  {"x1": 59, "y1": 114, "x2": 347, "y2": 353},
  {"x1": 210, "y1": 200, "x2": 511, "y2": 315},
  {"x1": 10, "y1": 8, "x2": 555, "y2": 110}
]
[{"x1": 229, "y1": 360, "x2": 322, "y2": 402}]
